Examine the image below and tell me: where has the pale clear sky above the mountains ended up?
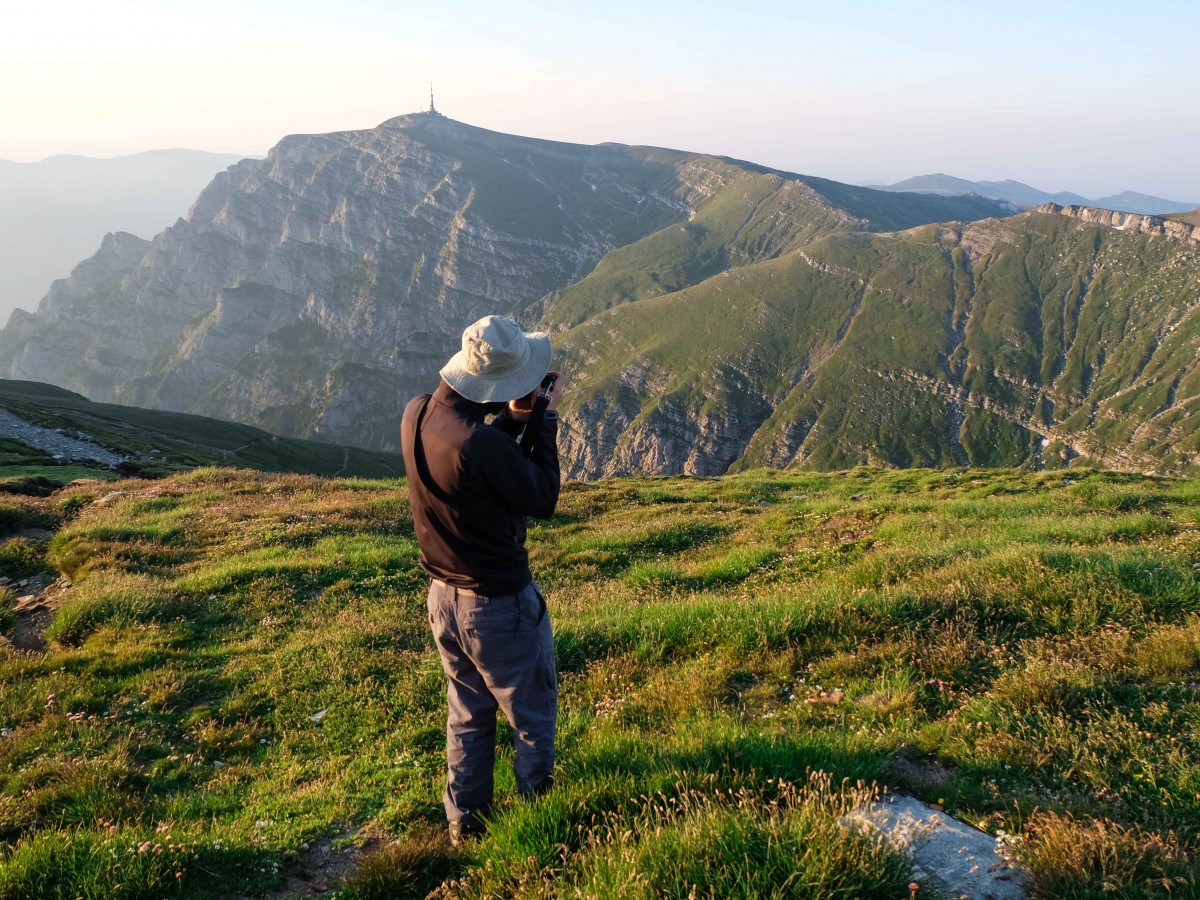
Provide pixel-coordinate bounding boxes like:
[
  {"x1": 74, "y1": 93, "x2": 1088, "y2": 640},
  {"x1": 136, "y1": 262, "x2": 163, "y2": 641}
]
[{"x1": 0, "y1": 0, "x2": 1200, "y2": 203}]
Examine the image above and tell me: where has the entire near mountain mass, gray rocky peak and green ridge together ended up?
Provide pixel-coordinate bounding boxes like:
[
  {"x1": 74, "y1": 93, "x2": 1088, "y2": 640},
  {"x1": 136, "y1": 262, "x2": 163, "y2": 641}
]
[{"x1": 0, "y1": 114, "x2": 1200, "y2": 478}]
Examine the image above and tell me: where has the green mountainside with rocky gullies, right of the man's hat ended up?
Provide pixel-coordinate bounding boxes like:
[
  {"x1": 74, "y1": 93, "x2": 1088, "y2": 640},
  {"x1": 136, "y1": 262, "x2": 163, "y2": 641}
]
[{"x1": 563, "y1": 214, "x2": 1200, "y2": 480}]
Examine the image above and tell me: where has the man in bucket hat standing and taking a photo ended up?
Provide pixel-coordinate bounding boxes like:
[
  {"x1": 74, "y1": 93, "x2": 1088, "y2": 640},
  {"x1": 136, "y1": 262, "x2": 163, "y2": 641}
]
[{"x1": 401, "y1": 316, "x2": 563, "y2": 846}]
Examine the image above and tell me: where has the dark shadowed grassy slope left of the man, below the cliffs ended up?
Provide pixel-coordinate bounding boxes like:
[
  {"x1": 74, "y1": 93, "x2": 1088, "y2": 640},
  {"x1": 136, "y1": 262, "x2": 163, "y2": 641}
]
[{"x1": 0, "y1": 379, "x2": 404, "y2": 481}]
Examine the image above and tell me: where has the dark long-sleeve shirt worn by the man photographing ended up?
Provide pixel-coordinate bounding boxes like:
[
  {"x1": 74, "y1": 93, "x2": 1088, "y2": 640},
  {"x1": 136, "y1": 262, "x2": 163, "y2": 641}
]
[{"x1": 400, "y1": 382, "x2": 560, "y2": 595}]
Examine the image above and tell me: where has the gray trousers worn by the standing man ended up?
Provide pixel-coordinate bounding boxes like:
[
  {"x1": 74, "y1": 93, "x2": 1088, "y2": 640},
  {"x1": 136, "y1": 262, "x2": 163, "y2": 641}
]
[{"x1": 428, "y1": 581, "x2": 558, "y2": 826}]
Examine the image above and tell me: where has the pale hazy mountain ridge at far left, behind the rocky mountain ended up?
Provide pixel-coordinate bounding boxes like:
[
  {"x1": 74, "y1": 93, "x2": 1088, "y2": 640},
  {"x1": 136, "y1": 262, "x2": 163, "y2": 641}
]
[{"x1": 0, "y1": 150, "x2": 249, "y2": 325}]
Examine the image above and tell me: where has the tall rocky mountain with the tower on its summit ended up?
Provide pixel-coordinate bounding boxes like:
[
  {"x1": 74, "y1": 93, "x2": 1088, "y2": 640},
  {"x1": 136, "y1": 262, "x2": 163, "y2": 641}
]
[{"x1": 0, "y1": 114, "x2": 1002, "y2": 451}]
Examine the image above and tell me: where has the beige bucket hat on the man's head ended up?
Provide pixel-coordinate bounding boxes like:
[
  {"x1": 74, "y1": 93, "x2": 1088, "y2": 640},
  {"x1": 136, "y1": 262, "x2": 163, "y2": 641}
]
[{"x1": 440, "y1": 316, "x2": 552, "y2": 403}]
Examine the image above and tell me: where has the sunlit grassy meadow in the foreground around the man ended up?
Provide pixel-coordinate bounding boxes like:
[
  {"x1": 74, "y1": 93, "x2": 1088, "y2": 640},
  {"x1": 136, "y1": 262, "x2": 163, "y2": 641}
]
[{"x1": 0, "y1": 468, "x2": 1200, "y2": 900}]
